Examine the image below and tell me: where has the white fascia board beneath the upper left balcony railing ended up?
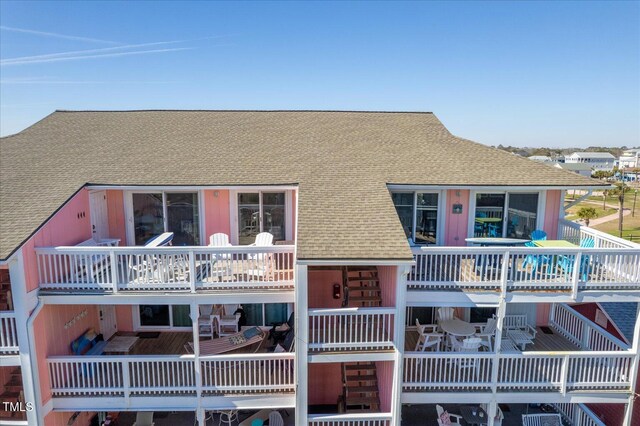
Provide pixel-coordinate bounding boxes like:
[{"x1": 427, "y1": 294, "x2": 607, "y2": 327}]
[{"x1": 40, "y1": 290, "x2": 295, "y2": 305}]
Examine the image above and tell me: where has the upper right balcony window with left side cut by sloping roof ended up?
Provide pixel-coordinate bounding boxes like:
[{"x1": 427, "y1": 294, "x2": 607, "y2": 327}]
[{"x1": 391, "y1": 192, "x2": 439, "y2": 244}]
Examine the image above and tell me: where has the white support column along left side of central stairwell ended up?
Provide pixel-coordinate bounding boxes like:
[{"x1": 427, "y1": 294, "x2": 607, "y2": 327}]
[{"x1": 295, "y1": 265, "x2": 309, "y2": 425}]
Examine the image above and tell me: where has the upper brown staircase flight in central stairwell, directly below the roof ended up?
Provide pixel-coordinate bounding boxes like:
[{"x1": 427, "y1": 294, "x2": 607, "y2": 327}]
[{"x1": 342, "y1": 266, "x2": 382, "y2": 308}]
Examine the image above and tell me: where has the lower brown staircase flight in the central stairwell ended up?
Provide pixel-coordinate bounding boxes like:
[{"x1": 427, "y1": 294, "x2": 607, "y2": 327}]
[{"x1": 339, "y1": 362, "x2": 380, "y2": 413}]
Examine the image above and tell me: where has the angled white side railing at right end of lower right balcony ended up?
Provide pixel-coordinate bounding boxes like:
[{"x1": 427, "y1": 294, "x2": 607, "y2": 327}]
[{"x1": 549, "y1": 303, "x2": 629, "y2": 351}]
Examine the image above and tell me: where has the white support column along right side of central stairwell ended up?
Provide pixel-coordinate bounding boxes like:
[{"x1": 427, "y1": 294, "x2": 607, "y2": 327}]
[{"x1": 391, "y1": 265, "x2": 411, "y2": 425}]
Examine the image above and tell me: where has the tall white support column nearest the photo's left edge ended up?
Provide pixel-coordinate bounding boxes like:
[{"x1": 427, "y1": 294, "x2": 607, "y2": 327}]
[{"x1": 9, "y1": 253, "x2": 39, "y2": 425}]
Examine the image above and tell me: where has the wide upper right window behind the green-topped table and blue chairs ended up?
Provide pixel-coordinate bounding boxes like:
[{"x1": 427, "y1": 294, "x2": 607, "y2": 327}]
[{"x1": 473, "y1": 192, "x2": 538, "y2": 238}]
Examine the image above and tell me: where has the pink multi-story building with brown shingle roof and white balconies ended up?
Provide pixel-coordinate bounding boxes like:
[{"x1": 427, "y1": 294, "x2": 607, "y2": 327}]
[{"x1": 0, "y1": 111, "x2": 640, "y2": 426}]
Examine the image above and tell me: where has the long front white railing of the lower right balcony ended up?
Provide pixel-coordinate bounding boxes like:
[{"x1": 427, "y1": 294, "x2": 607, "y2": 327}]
[{"x1": 403, "y1": 352, "x2": 634, "y2": 393}]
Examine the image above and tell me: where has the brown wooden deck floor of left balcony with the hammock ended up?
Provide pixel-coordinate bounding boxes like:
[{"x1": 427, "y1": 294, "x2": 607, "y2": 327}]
[{"x1": 116, "y1": 331, "x2": 270, "y2": 355}]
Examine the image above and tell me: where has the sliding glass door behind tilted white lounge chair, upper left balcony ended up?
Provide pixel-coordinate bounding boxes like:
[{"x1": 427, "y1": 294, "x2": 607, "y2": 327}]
[{"x1": 130, "y1": 192, "x2": 200, "y2": 246}]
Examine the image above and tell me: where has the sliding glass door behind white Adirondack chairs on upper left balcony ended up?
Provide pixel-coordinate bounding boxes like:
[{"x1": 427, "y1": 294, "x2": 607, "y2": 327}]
[{"x1": 238, "y1": 192, "x2": 286, "y2": 245}]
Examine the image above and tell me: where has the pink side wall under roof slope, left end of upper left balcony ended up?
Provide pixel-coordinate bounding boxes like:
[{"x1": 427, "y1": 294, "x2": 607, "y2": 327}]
[{"x1": 22, "y1": 189, "x2": 91, "y2": 292}]
